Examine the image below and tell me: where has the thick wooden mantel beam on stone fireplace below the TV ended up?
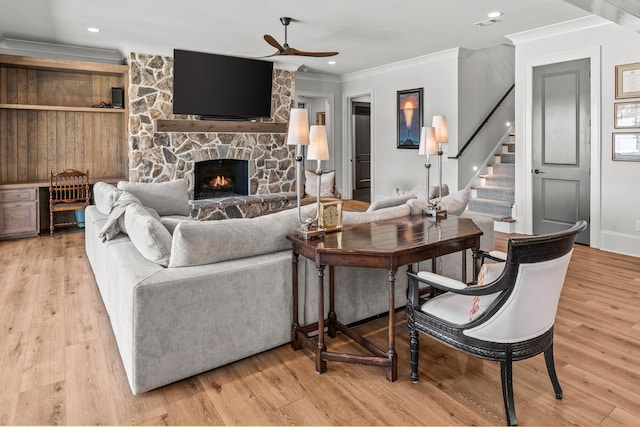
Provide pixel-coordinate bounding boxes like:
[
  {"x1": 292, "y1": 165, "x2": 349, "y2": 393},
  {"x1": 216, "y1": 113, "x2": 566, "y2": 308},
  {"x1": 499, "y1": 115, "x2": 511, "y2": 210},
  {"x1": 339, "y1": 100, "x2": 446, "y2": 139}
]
[{"x1": 155, "y1": 119, "x2": 288, "y2": 133}]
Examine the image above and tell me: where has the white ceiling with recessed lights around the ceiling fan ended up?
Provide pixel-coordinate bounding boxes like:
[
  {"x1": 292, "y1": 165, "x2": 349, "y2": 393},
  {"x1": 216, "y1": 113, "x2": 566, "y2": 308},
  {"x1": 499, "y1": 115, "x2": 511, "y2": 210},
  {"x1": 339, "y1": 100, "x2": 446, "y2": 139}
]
[{"x1": 0, "y1": 0, "x2": 590, "y2": 75}]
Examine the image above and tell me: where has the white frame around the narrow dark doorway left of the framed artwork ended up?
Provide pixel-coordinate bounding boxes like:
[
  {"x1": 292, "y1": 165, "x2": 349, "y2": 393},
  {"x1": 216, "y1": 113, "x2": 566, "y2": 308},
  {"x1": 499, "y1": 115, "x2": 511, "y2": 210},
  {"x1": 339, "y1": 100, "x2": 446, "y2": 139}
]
[{"x1": 340, "y1": 88, "x2": 376, "y2": 200}]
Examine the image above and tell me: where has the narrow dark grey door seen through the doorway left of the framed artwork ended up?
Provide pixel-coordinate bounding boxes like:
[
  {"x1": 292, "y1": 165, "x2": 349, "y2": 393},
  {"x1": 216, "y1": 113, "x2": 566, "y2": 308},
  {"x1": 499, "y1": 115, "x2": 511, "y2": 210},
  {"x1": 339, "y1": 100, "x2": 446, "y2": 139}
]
[{"x1": 352, "y1": 102, "x2": 371, "y2": 202}]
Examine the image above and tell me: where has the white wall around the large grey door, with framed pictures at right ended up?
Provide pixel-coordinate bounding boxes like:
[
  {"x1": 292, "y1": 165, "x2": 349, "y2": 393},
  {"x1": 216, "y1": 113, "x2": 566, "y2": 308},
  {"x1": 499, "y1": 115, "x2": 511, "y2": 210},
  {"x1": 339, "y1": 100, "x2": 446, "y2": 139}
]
[{"x1": 511, "y1": 16, "x2": 640, "y2": 256}]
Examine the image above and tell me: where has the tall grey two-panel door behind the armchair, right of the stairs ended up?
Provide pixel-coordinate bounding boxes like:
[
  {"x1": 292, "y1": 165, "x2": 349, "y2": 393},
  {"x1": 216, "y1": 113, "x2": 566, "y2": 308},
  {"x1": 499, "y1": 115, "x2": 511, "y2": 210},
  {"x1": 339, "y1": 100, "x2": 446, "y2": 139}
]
[{"x1": 531, "y1": 59, "x2": 591, "y2": 244}]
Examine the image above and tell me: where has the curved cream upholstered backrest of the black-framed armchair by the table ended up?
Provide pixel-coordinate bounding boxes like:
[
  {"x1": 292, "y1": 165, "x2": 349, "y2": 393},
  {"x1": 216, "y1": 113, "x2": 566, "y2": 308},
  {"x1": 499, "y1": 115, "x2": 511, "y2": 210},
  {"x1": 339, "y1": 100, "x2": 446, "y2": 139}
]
[{"x1": 464, "y1": 221, "x2": 587, "y2": 342}]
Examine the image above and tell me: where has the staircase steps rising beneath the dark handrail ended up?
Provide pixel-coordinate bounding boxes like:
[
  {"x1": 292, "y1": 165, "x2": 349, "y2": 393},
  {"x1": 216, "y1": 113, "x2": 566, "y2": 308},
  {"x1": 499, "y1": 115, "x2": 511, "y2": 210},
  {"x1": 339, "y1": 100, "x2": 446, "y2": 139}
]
[{"x1": 468, "y1": 133, "x2": 516, "y2": 233}]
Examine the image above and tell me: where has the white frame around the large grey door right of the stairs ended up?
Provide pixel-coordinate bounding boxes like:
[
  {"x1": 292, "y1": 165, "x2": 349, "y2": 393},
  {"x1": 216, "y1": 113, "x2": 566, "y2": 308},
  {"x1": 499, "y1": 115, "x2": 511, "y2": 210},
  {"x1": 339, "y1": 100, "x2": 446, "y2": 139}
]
[{"x1": 516, "y1": 46, "x2": 602, "y2": 248}]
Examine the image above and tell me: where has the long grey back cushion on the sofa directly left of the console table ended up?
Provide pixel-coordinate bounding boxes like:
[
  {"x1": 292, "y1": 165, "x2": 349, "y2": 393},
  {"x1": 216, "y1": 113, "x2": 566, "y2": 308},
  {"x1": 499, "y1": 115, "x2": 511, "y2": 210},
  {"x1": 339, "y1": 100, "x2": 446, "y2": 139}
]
[{"x1": 169, "y1": 204, "x2": 315, "y2": 267}]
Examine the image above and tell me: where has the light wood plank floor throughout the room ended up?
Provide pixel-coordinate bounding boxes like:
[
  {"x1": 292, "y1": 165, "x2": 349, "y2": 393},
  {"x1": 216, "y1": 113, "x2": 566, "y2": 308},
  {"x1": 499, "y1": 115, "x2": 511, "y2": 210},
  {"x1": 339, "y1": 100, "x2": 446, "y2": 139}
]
[{"x1": 0, "y1": 229, "x2": 640, "y2": 425}]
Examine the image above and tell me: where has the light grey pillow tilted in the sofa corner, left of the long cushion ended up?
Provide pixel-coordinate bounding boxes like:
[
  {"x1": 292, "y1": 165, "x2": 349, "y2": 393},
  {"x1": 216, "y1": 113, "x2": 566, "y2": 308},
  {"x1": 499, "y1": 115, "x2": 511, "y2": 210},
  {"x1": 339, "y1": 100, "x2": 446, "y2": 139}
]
[{"x1": 124, "y1": 204, "x2": 171, "y2": 267}]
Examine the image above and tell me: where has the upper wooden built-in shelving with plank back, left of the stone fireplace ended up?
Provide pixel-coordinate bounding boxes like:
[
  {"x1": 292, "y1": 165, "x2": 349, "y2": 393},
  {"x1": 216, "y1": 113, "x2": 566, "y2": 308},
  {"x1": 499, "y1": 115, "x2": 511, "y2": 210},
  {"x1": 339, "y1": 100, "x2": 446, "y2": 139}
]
[{"x1": 0, "y1": 55, "x2": 128, "y2": 185}]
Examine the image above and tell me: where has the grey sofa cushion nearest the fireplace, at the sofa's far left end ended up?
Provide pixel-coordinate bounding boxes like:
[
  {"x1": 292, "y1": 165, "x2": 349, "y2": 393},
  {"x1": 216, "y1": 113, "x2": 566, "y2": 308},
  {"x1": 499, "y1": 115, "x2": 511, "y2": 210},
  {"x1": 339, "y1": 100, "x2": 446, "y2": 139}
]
[{"x1": 118, "y1": 179, "x2": 189, "y2": 216}]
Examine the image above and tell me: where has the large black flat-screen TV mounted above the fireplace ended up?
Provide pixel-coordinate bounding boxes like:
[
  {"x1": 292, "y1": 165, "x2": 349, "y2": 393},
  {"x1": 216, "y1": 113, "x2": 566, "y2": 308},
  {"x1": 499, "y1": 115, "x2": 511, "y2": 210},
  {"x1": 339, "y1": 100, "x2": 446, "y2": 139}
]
[{"x1": 173, "y1": 49, "x2": 273, "y2": 120}]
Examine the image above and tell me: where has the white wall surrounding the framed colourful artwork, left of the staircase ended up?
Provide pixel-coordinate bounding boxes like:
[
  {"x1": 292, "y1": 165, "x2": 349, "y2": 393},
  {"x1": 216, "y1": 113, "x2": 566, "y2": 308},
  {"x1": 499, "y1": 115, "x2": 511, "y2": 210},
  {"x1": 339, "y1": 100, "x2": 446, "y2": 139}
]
[{"x1": 342, "y1": 49, "x2": 458, "y2": 200}]
